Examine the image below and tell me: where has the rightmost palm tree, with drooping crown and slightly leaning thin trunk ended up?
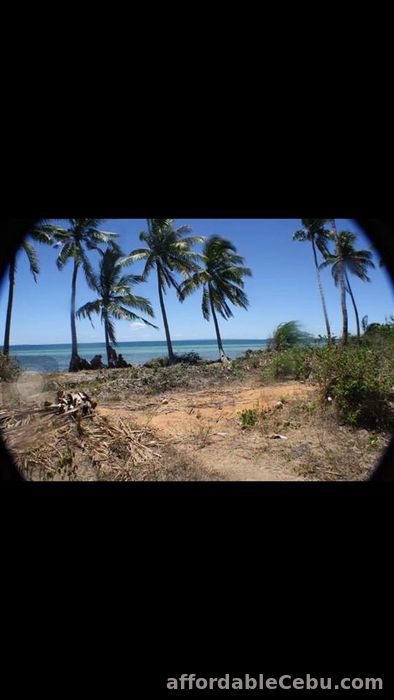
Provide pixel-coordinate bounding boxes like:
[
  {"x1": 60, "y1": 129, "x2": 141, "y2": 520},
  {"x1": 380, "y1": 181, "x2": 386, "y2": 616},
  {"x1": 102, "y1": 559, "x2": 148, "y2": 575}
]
[{"x1": 320, "y1": 231, "x2": 375, "y2": 342}]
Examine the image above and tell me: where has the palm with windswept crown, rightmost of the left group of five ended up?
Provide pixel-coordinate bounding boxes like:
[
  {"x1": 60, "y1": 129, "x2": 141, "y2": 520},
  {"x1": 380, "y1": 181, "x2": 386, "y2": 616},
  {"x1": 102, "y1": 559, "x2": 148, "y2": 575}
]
[{"x1": 181, "y1": 236, "x2": 252, "y2": 362}]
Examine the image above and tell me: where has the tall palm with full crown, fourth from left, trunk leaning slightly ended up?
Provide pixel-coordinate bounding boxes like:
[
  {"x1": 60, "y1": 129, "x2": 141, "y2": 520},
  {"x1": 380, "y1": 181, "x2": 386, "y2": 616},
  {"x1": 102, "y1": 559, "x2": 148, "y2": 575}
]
[{"x1": 130, "y1": 219, "x2": 204, "y2": 364}]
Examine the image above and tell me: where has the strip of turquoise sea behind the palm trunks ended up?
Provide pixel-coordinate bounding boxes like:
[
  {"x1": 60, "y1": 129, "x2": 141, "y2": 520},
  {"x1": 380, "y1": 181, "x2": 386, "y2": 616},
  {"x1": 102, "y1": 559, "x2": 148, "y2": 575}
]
[{"x1": 10, "y1": 339, "x2": 268, "y2": 372}]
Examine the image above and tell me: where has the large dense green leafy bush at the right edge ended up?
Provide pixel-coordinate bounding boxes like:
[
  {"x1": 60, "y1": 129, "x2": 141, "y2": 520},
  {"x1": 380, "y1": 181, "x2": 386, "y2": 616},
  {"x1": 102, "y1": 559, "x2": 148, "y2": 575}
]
[{"x1": 312, "y1": 345, "x2": 393, "y2": 428}]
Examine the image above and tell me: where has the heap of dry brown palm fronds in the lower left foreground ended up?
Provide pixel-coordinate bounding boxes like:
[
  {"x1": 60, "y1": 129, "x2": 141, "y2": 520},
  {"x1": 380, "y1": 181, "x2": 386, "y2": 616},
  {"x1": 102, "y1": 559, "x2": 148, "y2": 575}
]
[{"x1": 0, "y1": 392, "x2": 217, "y2": 481}]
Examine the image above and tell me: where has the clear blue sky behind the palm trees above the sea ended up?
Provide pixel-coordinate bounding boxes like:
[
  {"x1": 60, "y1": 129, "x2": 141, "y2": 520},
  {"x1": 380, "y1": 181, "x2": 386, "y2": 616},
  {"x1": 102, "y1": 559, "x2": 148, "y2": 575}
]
[{"x1": 0, "y1": 219, "x2": 394, "y2": 345}]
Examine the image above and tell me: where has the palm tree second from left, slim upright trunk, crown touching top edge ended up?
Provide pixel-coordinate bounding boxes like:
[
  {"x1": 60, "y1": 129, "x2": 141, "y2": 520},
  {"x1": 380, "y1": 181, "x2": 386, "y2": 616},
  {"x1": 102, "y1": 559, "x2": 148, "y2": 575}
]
[{"x1": 33, "y1": 219, "x2": 118, "y2": 372}]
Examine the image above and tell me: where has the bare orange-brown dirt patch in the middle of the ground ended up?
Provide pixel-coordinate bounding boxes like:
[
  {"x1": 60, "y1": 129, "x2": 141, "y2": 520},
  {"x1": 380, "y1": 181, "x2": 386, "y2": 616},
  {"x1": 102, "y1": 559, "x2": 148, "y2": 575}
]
[{"x1": 98, "y1": 382, "x2": 312, "y2": 481}]
